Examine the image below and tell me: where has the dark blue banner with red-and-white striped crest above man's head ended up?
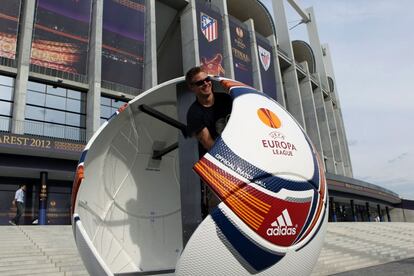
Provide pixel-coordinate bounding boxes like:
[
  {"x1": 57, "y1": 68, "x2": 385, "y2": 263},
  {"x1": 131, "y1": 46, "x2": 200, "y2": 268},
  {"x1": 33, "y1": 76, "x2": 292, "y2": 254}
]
[{"x1": 196, "y1": 1, "x2": 225, "y2": 76}]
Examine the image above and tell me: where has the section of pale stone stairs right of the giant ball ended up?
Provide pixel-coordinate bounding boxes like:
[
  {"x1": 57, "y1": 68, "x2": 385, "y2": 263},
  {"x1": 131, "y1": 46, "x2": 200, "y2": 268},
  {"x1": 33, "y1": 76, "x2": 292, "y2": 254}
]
[{"x1": 312, "y1": 222, "x2": 414, "y2": 276}]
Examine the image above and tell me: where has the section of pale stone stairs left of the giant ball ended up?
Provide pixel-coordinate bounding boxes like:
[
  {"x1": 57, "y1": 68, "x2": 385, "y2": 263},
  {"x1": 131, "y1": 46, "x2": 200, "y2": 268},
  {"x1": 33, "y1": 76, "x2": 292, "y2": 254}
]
[{"x1": 0, "y1": 225, "x2": 89, "y2": 276}]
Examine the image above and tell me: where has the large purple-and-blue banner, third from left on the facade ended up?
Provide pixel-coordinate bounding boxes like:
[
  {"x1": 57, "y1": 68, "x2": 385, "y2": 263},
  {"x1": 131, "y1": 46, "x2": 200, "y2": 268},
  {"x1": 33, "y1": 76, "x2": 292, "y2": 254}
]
[{"x1": 102, "y1": 0, "x2": 145, "y2": 89}]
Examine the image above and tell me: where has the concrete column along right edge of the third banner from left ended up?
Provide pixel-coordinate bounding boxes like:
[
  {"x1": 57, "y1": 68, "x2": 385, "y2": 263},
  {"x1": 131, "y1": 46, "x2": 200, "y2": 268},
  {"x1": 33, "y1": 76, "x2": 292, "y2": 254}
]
[{"x1": 144, "y1": 0, "x2": 158, "y2": 90}]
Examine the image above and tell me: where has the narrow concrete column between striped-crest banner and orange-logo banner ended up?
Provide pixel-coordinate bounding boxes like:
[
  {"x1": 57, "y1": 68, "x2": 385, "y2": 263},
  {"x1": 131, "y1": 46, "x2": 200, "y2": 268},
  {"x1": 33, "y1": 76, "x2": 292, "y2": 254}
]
[{"x1": 211, "y1": 0, "x2": 234, "y2": 79}]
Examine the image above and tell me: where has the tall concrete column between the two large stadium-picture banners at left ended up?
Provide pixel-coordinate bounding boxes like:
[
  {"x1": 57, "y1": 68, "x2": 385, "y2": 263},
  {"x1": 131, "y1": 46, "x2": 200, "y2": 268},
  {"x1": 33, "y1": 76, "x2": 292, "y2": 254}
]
[{"x1": 86, "y1": 0, "x2": 103, "y2": 140}]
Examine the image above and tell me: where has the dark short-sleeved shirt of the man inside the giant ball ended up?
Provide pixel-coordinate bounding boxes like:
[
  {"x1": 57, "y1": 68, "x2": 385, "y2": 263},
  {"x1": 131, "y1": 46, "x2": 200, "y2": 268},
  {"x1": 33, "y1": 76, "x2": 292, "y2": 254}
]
[{"x1": 187, "y1": 93, "x2": 233, "y2": 156}]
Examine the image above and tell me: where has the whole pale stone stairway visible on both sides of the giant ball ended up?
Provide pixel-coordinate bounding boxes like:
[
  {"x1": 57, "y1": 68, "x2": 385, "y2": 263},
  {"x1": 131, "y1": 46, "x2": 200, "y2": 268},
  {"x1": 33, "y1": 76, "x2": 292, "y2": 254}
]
[{"x1": 0, "y1": 222, "x2": 414, "y2": 276}]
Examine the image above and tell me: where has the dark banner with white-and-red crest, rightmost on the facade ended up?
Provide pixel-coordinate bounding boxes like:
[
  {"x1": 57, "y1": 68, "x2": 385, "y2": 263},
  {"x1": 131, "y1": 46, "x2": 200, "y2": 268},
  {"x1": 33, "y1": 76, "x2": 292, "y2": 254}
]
[{"x1": 256, "y1": 33, "x2": 277, "y2": 100}]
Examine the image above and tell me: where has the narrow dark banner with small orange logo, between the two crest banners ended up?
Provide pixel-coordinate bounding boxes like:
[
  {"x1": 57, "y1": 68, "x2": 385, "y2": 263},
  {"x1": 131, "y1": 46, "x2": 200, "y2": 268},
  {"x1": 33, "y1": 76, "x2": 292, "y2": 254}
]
[{"x1": 229, "y1": 17, "x2": 253, "y2": 86}]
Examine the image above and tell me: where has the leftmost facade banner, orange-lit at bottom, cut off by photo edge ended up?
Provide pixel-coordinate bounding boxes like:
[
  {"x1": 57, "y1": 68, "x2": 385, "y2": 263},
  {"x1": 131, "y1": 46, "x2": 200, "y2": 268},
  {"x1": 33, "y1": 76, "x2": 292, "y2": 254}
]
[{"x1": 0, "y1": 0, "x2": 20, "y2": 62}]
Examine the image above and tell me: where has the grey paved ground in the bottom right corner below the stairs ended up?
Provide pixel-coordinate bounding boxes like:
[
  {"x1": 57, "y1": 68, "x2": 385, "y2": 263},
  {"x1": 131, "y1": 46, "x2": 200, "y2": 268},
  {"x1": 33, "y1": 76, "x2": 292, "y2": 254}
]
[{"x1": 333, "y1": 258, "x2": 414, "y2": 276}]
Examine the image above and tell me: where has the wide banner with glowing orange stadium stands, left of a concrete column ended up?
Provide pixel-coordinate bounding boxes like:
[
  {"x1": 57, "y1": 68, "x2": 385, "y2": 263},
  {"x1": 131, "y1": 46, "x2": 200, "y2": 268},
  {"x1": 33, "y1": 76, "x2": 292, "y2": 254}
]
[{"x1": 30, "y1": 0, "x2": 92, "y2": 75}]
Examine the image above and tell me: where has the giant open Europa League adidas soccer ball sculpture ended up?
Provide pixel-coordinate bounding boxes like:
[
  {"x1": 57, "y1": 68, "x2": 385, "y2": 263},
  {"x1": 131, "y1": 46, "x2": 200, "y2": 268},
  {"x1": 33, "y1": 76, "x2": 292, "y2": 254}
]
[{"x1": 72, "y1": 78, "x2": 327, "y2": 275}]
